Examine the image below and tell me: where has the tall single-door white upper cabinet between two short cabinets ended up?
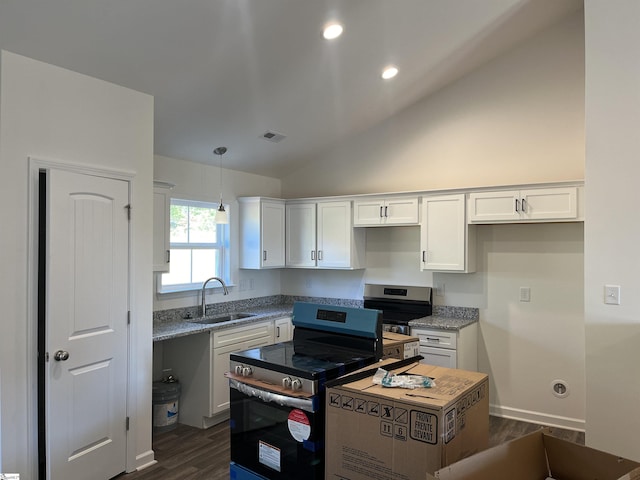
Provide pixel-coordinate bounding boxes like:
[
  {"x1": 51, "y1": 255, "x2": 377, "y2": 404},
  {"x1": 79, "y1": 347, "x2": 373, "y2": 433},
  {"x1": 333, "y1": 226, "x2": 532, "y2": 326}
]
[{"x1": 420, "y1": 193, "x2": 476, "y2": 273}]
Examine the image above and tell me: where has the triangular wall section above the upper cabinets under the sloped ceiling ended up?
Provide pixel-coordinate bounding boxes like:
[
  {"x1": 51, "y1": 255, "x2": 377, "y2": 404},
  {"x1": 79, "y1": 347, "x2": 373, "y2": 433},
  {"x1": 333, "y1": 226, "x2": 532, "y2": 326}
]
[{"x1": 282, "y1": 15, "x2": 584, "y2": 198}]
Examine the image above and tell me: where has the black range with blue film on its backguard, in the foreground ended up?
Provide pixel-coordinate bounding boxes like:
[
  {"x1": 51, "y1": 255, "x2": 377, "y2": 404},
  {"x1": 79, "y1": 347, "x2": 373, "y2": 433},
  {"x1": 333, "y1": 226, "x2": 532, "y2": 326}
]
[{"x1": 227, "y1": 302, "x2": 382, "y2": 480}]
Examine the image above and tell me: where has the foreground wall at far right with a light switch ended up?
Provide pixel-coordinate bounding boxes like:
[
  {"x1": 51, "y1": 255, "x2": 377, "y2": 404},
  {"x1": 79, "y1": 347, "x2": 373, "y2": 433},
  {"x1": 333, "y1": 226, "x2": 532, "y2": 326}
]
[{"x1": 584, "y1": 0, "x2": 640, "y2": 461}]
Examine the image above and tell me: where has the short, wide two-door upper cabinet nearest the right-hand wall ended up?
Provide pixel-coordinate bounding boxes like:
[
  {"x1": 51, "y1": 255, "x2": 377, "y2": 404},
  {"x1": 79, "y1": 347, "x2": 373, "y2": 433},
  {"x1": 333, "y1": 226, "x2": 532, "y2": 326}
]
[{"x1": 468, "y1": 186, "x2": 582, "y2": 223}]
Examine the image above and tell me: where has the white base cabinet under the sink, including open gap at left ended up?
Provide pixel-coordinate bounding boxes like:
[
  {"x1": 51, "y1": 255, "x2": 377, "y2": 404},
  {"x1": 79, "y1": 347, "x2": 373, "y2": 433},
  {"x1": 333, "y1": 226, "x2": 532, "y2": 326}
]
[{"x1": 162, "y1": 321, "x2": 274, "y2": 428}]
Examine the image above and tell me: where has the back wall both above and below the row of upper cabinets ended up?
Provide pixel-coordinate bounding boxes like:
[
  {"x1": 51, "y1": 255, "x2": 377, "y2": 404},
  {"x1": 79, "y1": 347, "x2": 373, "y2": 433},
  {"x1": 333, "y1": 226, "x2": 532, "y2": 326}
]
[{"x1": 282, "y1": 15, "x2": 591, "y2": 429}]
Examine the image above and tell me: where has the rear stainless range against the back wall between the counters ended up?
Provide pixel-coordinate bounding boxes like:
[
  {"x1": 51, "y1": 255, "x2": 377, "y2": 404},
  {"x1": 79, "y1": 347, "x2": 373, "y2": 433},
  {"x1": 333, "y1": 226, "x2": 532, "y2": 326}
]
[{"x1": 364, "y1": 283, "x2": 433, "y2": 335}]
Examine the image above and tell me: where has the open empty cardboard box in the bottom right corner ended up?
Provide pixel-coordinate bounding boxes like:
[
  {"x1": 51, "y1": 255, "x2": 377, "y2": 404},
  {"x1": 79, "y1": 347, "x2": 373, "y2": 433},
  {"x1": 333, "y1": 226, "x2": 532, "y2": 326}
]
[{"x1": 426, "y1": 429, "x2": 640, "y2": 480}]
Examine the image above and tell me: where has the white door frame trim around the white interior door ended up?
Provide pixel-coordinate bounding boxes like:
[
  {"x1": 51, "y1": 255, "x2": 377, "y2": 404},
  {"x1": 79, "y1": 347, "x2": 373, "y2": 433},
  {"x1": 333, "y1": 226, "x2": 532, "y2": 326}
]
[{"x1": 26, "y1": 156, "x2": 137, "y2": 479}]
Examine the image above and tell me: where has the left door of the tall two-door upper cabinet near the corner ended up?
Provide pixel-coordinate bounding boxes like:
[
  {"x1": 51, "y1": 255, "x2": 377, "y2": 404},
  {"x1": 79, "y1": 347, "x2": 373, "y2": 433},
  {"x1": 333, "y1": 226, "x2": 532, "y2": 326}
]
[{"x1": 285, "y1": 203, "x2": 316, "y2": 267}]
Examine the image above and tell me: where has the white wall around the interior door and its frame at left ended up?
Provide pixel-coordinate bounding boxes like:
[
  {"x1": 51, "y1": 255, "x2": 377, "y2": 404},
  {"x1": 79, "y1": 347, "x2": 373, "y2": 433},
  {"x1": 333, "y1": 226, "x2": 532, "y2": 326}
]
[{"x1": 0, "y1": 51, "x2": 153, "y2": 480}]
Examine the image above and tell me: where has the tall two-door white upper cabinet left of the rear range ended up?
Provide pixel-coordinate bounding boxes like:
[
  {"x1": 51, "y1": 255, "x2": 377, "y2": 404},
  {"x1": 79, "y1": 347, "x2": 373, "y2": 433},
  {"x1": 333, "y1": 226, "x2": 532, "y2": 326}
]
[{"x1": 285, "y1": 201, "x2": 365, "y2": 269}]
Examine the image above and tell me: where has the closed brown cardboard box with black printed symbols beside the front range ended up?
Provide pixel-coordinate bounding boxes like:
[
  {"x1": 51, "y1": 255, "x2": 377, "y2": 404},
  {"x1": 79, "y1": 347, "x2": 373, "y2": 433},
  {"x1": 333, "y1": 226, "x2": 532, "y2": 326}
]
[{"x1": 325, "y1": 363, "x2": 489, "y2": 480}]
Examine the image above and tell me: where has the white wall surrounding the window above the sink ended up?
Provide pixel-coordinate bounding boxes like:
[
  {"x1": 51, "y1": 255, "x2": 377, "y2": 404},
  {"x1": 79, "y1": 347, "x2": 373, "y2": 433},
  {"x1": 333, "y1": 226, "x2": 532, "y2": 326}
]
[{"x1": 152, "y1": 154, "x2": 281, "y2": 310}]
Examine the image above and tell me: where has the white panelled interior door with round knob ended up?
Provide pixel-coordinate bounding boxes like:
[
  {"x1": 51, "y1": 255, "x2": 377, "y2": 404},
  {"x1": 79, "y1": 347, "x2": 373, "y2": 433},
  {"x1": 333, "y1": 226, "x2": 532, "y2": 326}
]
[{"x1": 45, "y1": 169, "x2": 129, "y2": 480}]
